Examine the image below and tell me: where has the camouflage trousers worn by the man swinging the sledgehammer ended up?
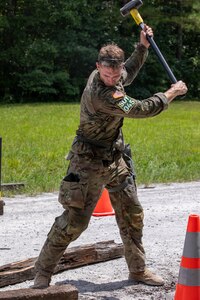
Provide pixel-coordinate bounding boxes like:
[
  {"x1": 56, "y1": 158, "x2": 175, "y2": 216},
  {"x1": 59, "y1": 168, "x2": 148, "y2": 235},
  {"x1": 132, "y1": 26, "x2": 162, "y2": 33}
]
[{"x1": 35, "y1": 154, "x2": 145, "y2": 274}]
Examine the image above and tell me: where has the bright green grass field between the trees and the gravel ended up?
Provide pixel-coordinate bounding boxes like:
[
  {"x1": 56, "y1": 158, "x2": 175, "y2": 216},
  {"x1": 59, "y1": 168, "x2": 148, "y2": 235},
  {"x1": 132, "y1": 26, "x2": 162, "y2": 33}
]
[{"x1": 0, "y1": 101, "x2": 200, "y2": 194}]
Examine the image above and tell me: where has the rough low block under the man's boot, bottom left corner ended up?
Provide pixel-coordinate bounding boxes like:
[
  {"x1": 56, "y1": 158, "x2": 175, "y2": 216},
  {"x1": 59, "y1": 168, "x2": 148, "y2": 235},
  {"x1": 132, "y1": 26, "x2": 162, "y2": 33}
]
[{"x1": 0, "y1": 284, "x2": 78, "y2": 300}]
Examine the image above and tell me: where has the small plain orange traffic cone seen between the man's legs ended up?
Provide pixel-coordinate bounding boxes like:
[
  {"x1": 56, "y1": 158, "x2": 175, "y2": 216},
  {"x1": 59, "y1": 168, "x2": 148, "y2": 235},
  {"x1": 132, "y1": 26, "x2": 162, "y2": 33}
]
[{"x1": 92, "y1": 189, "x2": 115, "y2": 217}]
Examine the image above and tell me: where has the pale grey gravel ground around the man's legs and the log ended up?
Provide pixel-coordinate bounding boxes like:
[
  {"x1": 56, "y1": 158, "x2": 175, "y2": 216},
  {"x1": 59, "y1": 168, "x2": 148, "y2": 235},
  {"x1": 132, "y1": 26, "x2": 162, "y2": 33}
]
[{"x1": 0, "y1": 182, "x2": 200, "y2": 300}]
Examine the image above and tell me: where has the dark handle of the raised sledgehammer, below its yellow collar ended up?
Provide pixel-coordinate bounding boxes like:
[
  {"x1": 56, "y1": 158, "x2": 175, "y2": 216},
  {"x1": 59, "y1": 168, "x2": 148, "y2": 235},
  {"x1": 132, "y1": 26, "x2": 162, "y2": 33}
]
[{"x1": 140, "y1": 23, "x2": 177, "y2": 83}]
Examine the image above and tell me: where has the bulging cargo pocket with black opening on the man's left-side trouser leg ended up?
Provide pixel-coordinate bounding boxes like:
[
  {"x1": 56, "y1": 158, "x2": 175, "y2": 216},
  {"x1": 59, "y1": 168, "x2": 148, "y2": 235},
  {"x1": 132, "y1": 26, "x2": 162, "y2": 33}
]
[{"x1": 58, "y1": 173, "x2": 87, "y2": 209}]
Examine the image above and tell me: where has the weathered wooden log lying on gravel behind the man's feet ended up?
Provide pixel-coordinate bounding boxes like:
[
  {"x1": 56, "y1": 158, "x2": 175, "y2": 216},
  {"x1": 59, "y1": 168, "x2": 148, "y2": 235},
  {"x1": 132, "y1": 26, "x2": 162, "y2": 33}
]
[{"x1": 0, "y1": 241, "x2": 124, "y2": 287}]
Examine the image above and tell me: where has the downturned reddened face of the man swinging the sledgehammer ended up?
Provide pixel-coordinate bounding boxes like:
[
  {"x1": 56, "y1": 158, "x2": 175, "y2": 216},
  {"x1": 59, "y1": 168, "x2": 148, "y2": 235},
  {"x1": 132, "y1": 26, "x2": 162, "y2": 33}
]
[{"x1": 97, "y1": 63, "x2": 123, "y2": 86}]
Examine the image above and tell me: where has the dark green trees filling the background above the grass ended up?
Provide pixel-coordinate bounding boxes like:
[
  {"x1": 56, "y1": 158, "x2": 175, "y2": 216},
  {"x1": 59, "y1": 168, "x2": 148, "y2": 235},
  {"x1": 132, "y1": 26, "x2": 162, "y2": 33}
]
[{"x1": 0, "y1": 0, "x2": 200, "y2": 103}]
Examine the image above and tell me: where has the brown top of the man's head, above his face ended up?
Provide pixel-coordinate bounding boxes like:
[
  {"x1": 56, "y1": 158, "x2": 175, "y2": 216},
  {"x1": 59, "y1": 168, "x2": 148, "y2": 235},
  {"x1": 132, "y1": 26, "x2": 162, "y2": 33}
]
[{"x1": 98, "y1": 43, "x2": 124, "y2": 68}]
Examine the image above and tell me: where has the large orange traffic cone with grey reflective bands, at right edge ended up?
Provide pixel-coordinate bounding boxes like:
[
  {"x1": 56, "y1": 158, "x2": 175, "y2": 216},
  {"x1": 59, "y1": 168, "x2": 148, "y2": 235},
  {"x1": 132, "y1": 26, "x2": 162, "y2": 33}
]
[{"x1": 174, "y1": 215, "x2": 200, "y2": 300}]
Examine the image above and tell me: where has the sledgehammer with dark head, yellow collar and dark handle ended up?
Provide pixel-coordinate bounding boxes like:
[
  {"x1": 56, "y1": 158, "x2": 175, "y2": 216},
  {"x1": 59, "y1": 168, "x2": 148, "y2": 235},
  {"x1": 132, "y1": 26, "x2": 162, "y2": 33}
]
[{"x1": 120, "y1": 0, "x2": 177, "y2": 83}]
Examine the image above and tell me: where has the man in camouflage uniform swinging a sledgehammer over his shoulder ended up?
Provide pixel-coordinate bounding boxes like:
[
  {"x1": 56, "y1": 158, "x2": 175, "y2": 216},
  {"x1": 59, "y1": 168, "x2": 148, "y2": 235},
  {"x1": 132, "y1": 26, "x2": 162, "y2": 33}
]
[{"x1": 33, "y1": 26, "x2": 187, "y2": 288}]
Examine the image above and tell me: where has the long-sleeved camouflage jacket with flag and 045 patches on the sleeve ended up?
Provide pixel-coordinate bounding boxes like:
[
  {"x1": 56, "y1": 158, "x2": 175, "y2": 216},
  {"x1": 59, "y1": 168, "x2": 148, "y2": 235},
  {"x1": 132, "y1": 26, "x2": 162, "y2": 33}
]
[{"x1": 71, "y1": 44, "x2": 168, "y2": 159}]
